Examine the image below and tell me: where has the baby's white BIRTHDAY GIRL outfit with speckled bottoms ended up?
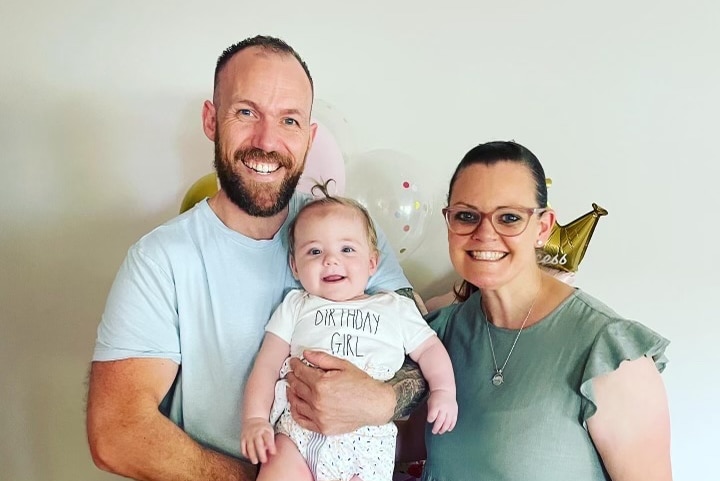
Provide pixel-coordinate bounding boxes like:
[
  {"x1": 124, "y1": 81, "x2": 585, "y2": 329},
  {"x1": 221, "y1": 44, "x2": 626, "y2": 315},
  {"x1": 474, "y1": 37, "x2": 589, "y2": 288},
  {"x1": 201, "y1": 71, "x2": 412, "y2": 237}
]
[{"x1": 265, "y1": 290, "x2": 435, "y2": 481}]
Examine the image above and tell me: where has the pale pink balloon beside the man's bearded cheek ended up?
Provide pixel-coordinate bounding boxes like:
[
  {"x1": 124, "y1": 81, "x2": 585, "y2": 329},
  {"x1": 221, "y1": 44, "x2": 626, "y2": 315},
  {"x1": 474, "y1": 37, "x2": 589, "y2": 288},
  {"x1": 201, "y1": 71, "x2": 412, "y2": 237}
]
[{"x1": 297, "y1": 121, "x2": 345, "y2": 195}]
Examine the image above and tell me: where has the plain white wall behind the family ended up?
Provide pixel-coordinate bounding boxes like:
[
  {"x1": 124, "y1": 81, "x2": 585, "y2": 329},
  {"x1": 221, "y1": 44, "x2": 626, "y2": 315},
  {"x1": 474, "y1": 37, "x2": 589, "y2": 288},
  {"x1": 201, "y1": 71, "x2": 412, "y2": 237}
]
[{"x1": 0, "y1": 0, "x2": 720, "y2": 481}]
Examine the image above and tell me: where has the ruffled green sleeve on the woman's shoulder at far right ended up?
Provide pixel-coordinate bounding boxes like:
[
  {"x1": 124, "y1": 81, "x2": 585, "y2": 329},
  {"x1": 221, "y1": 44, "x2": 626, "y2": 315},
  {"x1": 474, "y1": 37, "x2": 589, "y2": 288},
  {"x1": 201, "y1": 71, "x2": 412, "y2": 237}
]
[{"x1": 580, "y1": 320, "x2": 670, "y2": 422}]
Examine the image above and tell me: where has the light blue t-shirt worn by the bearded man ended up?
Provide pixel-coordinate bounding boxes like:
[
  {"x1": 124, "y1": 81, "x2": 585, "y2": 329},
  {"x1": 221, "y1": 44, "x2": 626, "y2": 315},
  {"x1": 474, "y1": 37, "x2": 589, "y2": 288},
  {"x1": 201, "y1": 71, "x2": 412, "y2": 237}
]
[{"x1": 93, "y1": 194, "x2": 410, "y2": 457}]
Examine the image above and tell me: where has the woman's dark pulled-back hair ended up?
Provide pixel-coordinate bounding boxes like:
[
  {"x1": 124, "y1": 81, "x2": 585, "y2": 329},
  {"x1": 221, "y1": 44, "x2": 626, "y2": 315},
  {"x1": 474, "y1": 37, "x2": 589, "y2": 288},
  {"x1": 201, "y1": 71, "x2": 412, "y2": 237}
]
[{"x1": 447, "y1": 140, "x2": 547, "y2": 302}]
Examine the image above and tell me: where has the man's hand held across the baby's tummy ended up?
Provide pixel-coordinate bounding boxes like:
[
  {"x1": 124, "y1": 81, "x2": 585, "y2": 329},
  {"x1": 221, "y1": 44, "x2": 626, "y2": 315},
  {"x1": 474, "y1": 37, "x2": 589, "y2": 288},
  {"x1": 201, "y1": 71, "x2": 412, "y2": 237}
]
[{"x1": 287, "y1": 351, "x2": 396, "y2": 435}]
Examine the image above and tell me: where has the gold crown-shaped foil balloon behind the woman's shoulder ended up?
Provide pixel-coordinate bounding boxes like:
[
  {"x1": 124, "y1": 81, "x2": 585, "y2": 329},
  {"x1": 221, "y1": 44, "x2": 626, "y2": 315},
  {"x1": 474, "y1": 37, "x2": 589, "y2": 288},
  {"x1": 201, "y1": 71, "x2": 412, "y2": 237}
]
[{"x1": 537, "y1": 203, "x2": 608, "y2": 272}]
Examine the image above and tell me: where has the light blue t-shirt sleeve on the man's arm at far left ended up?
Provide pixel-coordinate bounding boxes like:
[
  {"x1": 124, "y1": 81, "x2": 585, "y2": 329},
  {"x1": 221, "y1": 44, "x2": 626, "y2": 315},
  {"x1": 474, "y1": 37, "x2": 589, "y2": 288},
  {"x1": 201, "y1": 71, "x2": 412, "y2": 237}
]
[{"x1": 93, "y1": 245, "x2": 181, "y2": 364}]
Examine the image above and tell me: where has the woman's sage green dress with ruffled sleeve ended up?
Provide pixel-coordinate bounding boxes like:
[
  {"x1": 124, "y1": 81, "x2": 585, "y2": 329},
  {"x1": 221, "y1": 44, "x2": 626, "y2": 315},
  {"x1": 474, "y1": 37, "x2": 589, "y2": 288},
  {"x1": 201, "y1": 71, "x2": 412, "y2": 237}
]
[{"x1": 422, "y1": 289, "x2": 669, "y2": 481}]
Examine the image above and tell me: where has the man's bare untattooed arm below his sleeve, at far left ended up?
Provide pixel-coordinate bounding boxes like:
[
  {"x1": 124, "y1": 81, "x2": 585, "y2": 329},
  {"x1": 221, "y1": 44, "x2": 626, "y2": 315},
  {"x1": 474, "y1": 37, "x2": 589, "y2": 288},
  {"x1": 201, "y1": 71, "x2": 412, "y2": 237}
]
[{"x1": 87, "y1": 359, "x2": 256, "y2": 481}]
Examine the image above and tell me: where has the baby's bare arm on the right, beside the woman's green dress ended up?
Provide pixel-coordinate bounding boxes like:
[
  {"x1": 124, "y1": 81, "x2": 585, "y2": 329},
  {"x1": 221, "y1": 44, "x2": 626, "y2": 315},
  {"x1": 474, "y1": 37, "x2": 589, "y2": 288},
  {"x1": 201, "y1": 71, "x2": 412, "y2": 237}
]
[{"x1": 410, "y1": 336, "x2": 458, "y2": 434}]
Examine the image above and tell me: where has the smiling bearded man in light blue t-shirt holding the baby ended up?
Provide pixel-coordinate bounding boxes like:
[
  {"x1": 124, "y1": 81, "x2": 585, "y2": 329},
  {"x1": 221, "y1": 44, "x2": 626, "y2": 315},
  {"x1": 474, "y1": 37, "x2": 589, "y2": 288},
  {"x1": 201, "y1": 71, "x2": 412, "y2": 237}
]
[{"x1": 87, "y1": 36, "x2": 424, "y2": 480}]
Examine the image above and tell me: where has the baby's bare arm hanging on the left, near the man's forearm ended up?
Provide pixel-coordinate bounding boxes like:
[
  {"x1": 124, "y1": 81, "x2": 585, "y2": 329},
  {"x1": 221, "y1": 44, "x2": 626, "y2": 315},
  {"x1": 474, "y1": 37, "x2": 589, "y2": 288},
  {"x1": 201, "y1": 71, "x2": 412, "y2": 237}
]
[{"x1": 240, "y1": 332, "x2": 290, "y2": 464}]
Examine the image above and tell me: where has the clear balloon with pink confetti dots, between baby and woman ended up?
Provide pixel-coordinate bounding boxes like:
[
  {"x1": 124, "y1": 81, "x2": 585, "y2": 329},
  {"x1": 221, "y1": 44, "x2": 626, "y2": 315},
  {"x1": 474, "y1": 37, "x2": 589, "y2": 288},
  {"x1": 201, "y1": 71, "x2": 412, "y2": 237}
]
[{"x1": 345, "y1": 149, "x2": 433, "y2": 261}]
